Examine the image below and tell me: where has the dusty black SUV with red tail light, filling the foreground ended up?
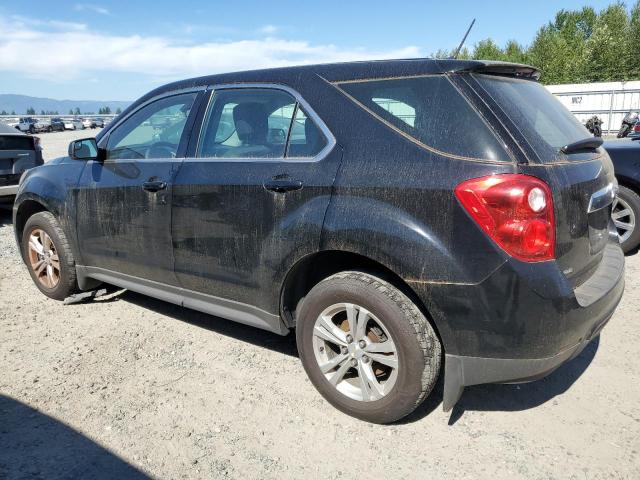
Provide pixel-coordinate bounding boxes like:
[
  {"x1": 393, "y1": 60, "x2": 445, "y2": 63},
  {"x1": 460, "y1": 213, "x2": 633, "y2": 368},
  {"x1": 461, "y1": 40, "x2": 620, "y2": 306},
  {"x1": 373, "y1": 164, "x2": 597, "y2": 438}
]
[{"x1": 13, "y1": 59, "x2": 624, "y2": 422}]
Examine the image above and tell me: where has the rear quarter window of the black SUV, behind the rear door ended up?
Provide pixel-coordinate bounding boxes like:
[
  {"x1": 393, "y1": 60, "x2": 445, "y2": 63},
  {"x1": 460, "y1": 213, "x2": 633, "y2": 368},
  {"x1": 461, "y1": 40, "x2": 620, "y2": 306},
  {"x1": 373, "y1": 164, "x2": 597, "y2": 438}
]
[{"x1": 338, "y1": 76, "x2": 510, "y2": 162}]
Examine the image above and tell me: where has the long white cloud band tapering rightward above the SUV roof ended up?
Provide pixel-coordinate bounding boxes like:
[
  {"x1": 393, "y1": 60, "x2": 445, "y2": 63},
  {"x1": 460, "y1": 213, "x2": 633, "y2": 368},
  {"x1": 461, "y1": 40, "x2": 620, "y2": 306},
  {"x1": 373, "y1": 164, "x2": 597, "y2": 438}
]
[{"x1": 0, "y1": 15, "x2": 422, "y2": 80}]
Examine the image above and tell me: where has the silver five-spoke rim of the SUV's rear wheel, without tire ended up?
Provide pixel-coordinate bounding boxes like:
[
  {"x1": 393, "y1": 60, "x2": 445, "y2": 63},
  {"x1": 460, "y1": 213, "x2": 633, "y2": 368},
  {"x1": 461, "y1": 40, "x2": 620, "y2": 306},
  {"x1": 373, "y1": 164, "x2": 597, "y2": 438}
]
[{"x1": 313, "y1": 303, "x2": 400, "y2": 402}]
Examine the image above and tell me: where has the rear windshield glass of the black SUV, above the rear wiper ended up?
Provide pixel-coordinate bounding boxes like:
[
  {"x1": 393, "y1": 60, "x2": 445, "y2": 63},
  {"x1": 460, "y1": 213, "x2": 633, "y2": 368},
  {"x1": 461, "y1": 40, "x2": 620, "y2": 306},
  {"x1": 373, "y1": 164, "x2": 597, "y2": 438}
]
[{"x1": 476, "y1": 75, "x2": 591, "y2": 162}]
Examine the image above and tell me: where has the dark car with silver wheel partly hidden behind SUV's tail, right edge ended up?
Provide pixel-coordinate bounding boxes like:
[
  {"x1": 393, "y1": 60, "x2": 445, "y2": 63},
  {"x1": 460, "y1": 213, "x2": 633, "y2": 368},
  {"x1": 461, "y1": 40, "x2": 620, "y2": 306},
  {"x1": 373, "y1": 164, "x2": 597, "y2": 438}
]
[{"x1": 604, "y1": 138, "x2": 640, "y2": 253}]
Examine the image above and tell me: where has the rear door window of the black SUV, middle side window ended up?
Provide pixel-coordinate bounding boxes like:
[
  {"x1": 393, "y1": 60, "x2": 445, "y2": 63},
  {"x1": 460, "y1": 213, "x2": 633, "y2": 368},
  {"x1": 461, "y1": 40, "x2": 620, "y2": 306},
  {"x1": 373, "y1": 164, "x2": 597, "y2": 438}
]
[{"x1": 198, "y1": 88, "x2": 327, "y2": 159}]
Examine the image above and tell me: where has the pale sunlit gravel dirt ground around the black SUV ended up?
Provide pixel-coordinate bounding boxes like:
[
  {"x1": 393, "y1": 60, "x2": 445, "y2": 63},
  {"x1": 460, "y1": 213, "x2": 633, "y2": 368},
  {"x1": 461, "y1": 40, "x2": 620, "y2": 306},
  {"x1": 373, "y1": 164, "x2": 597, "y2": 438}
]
[{"x1": 0, "y1": 132, "x2": 640, "y2": 479}]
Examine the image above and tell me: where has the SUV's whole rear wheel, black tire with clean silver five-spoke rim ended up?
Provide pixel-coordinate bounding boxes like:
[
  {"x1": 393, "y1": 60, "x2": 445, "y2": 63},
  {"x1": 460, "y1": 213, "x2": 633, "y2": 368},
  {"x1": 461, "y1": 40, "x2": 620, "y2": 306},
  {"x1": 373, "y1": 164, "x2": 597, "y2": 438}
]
[{"x1": 296, "y1": 272, "x2": 441, "y2": 423}]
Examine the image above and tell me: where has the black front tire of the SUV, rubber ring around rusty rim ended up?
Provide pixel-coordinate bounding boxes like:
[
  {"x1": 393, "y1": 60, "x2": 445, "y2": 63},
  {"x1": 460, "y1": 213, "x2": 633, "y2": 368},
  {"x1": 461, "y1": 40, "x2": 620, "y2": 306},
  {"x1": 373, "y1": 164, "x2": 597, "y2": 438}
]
[{"x1": 22, "y1": 212, "x2": 79, "y2": 300}]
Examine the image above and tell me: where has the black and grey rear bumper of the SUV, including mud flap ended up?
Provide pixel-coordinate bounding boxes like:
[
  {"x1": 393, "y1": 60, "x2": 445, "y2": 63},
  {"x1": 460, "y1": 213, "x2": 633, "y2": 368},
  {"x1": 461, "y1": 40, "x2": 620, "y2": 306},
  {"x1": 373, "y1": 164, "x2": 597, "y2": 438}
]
[{"x1": 414, "y1": 241, "x2": 624, "y2": 410}]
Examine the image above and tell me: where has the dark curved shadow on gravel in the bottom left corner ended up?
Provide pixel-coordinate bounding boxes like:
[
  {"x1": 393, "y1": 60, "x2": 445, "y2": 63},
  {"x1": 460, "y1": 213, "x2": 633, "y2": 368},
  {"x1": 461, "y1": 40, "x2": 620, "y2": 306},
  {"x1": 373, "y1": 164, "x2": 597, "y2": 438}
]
[{"x1": 0, "y1": 395, "x2": 149, "y2": 480}]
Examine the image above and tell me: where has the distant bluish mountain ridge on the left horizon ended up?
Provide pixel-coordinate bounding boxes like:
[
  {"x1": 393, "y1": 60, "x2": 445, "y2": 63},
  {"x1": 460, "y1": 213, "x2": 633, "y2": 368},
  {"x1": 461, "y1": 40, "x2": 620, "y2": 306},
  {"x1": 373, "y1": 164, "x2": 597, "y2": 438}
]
[{"x1": 0, "y1": 93, "x2": 131, "y2": 115}]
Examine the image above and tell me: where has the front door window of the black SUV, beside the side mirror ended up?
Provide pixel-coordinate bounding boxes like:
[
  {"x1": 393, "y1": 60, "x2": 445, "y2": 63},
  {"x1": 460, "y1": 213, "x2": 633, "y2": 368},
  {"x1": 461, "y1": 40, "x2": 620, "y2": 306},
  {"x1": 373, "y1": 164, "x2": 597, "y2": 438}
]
[{"x1": 107, "y1": 93, "x2": 197, "y2": 159}]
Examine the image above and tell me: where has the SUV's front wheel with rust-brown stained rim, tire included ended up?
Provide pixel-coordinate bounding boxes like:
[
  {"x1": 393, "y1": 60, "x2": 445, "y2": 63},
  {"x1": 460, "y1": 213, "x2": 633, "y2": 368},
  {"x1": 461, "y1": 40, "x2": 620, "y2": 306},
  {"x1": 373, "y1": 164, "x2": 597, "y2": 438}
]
[{"x1": 22, "y1": 212, "x2": 78, "y2": 300}]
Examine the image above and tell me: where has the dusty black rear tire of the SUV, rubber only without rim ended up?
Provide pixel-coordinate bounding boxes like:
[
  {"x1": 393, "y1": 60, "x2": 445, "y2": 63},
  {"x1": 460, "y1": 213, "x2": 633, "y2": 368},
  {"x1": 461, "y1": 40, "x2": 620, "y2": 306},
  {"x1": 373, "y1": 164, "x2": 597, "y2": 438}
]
[{"x1": 296, "y1": 271, "x2": 442, "y2": 423}]
